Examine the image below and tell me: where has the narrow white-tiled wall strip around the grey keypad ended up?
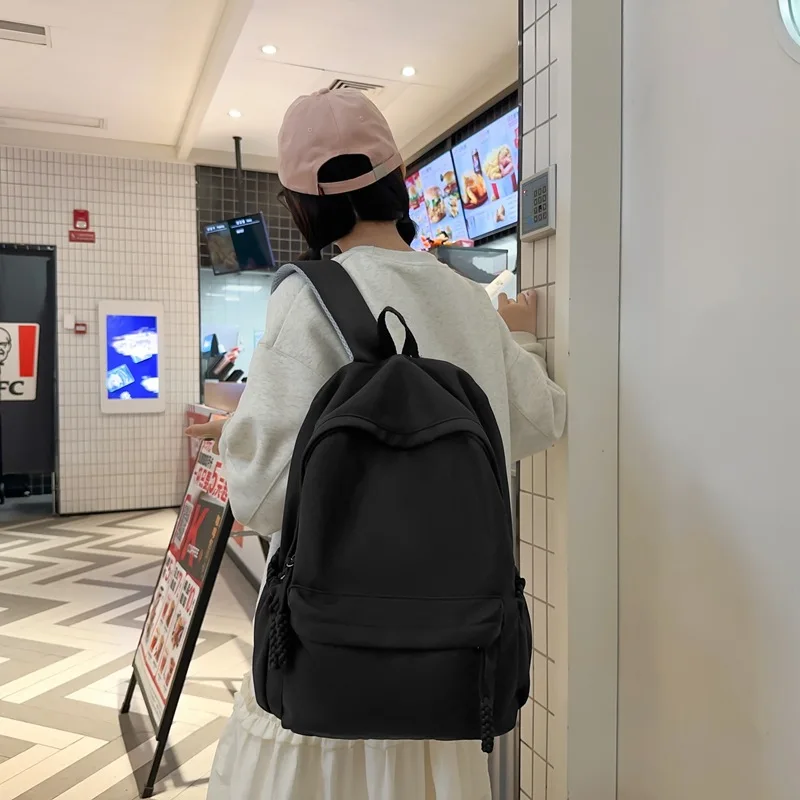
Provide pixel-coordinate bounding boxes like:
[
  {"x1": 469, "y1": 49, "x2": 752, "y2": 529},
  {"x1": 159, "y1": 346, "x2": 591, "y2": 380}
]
[{"x1": 520, "y1": 0, "x2": 565, "y2": 800}]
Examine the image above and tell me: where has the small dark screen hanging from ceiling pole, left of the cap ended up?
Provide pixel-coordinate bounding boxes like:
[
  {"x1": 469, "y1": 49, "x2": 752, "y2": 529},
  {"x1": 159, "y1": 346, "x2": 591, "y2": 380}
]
[{"x1": 204, "y1": 213, "x2": 275, "y2": 275}]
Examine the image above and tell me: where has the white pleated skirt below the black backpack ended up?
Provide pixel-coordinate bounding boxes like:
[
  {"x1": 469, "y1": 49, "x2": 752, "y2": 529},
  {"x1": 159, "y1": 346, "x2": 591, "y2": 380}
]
[{"x1": 207, "y1": 676, "x2": 491, "y2": 800}]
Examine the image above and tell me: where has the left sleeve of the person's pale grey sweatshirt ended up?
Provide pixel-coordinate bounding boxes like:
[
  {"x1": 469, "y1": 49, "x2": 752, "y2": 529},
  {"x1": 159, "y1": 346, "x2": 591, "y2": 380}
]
[{"x1": 220, "y1": 277, "x2": 346, "y2": 536}]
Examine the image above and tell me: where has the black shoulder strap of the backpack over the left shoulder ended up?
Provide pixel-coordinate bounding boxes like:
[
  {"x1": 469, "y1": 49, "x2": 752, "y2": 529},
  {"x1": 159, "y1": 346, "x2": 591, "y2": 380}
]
[{"x1": 272, "y1": 261, "x2": 381, "y2": 362}]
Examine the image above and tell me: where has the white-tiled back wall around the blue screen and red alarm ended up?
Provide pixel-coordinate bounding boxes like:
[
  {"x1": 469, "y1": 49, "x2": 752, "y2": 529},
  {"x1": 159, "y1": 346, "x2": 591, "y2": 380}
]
[{"x1": 0, "y1": 147, "x2": 199, "y2": 514}]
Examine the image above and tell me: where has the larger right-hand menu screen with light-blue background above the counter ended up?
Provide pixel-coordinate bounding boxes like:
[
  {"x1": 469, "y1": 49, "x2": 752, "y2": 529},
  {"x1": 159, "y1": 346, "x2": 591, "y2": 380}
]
[{"x1": 453, "y1": 108, "x2": 519, "y2": 239}]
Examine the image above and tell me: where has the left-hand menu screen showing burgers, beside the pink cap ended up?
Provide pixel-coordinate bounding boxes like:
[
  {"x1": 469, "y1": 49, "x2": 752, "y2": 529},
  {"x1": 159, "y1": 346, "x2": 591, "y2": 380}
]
[{"x1": 406, "y1": 153, "x2": 469, "y2": 250}]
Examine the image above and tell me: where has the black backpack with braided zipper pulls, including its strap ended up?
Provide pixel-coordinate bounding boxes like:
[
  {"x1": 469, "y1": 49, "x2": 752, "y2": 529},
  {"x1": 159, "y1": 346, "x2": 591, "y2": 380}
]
[{"x1": 253, "y1": 261, "x2": 531, "y2": 752}]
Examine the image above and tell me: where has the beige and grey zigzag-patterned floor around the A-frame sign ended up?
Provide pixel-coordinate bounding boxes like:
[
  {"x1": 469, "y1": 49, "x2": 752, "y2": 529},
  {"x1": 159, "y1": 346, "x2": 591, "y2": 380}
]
[{"x1": 0, "y1": 507, "x2": 256, "y2": 800}]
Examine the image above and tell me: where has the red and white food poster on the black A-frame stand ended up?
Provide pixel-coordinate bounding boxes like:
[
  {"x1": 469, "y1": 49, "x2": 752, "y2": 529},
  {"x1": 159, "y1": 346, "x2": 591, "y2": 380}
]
[{"x1": 134, "y1": 442, "x2": 231, "y2": 727}]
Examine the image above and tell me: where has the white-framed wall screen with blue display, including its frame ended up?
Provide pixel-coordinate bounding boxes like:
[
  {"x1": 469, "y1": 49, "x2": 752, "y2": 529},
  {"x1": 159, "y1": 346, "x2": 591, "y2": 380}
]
[{"x1": 99, "y1": 301, "x2": 166, "y2": 414}]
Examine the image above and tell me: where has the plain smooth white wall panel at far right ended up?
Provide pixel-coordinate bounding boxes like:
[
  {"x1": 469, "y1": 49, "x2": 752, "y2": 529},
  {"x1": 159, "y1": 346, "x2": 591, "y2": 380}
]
[{"x1": 619, "y1": 0, "x2": 800, "y2": 800}]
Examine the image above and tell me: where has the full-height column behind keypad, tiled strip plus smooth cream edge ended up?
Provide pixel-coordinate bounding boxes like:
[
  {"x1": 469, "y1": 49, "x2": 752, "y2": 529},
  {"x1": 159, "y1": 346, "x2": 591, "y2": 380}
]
[{"x1": 520, "y1": 0, "x2": 621, "y2": 800}]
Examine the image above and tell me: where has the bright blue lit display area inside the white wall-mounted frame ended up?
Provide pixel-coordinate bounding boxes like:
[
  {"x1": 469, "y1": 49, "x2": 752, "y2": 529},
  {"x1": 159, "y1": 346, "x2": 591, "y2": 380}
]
[{"x1": 106, "y1": 314, "x2": 159, "y2": 400}]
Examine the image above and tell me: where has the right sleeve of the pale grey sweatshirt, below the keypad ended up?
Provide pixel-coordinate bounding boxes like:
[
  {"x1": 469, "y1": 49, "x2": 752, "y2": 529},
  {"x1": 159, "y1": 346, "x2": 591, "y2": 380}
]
[{"x1": 498, "y1": 317, "x2": 567, "y2": 462}]
